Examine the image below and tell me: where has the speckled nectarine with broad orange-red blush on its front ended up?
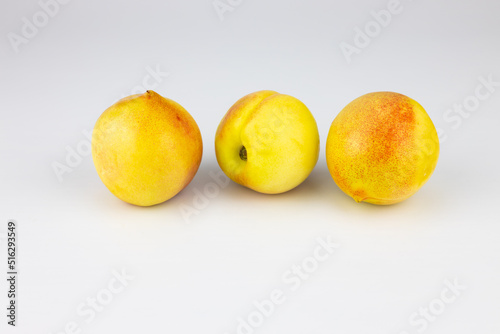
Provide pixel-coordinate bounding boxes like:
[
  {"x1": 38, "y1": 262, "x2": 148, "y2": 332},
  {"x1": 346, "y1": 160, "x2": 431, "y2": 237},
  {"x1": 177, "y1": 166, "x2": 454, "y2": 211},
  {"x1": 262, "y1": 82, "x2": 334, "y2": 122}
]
[{"x1": 326, "y1": 92, "x2": 439, "y2": 205}]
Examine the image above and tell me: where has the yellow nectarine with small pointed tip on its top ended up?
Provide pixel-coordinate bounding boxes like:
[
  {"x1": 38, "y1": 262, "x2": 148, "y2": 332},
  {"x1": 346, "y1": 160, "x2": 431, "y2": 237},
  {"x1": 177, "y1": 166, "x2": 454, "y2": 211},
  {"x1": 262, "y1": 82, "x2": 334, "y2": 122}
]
[{"x1": 92, "y1": 91, "x2": 203, "y2": 206}]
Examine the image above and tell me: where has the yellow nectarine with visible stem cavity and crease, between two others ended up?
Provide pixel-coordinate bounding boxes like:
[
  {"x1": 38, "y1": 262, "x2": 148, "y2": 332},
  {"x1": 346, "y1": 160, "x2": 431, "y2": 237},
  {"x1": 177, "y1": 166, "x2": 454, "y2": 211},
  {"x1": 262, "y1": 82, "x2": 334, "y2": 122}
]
[{"x1": 215, "y1": 90, "x2": 319, "y2": 194}]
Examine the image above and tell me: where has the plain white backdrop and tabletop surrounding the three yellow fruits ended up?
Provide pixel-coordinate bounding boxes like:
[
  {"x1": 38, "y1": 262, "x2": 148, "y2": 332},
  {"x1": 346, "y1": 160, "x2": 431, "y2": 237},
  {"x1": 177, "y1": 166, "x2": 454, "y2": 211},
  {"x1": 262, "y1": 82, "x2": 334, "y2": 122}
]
[{"x1": 0, "y1": 0, "x2": 500, "y2": 334}]
